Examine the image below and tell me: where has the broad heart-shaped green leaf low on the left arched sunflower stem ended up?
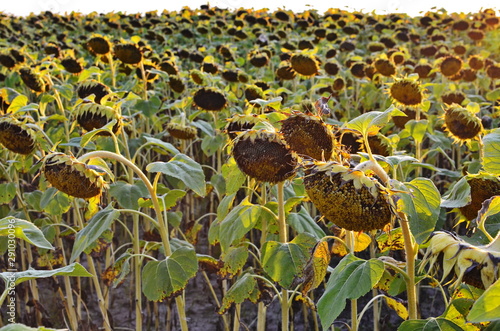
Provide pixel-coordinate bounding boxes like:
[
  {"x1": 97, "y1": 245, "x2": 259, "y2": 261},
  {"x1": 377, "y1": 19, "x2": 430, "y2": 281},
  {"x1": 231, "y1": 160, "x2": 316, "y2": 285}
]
[{"x1": 142, "y1": 246, "x2": 198, "y2": 301}]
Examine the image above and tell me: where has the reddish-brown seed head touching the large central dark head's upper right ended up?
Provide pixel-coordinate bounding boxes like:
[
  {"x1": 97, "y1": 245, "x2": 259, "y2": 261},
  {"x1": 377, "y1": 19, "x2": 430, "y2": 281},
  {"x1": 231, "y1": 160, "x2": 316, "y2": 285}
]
[{"x1": 281, "y1": 113, "x2": 333, "y2": 161}]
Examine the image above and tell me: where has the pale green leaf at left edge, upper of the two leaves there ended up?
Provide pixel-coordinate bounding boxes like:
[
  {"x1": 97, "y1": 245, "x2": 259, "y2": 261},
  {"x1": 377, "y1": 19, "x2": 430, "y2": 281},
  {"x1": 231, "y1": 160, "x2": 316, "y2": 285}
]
[{"x1": 0, "y1": 216, "x2": 54, "y2": 249}]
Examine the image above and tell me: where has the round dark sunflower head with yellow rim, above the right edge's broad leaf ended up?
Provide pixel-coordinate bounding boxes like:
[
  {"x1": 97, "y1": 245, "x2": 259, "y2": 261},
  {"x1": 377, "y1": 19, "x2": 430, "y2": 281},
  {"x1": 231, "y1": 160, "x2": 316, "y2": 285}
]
[{"x1": 443, "y1": 104, "x2": 483, "y2": 144}]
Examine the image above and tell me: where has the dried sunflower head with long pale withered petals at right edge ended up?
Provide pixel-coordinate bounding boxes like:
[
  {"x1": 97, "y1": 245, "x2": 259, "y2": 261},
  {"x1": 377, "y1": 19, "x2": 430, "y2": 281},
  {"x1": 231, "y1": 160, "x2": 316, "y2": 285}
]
[{"x1": 420, "y1": 231, "x2": 500, "y2": 289}]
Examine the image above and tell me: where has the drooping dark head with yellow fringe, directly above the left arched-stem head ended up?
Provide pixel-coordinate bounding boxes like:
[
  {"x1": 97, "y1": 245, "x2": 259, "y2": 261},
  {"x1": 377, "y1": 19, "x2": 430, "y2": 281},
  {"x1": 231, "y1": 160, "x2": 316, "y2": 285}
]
[{"x1": 73, "y1": 102, "x2": 122, "y2": 136}]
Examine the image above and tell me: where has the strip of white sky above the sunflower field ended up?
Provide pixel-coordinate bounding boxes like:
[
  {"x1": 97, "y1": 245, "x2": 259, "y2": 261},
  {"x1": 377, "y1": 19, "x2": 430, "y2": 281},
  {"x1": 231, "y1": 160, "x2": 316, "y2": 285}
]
[{"x1": 0, "y1": 0, "x2": 500, "y2": 16}]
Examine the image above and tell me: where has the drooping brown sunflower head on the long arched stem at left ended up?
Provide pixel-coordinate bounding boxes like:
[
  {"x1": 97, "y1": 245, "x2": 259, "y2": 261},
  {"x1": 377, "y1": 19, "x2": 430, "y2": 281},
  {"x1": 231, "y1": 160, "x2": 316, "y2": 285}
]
[{"x1": 42, "y1": 153, "x2": 107, "y2": 199}]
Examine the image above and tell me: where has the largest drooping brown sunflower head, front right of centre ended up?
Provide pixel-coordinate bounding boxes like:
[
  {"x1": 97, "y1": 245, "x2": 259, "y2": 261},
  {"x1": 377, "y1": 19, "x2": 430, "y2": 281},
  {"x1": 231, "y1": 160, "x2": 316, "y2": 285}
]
[{"x1": 304, "y1": 162, "x2": 394, "y2": 231}]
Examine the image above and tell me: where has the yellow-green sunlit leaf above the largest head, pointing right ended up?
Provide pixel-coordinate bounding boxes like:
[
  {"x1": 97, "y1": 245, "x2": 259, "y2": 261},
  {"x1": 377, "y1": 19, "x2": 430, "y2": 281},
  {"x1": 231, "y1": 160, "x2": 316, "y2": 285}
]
[{"x1": 346, "y1": 106, "x2": 405, "y2": 137}]
